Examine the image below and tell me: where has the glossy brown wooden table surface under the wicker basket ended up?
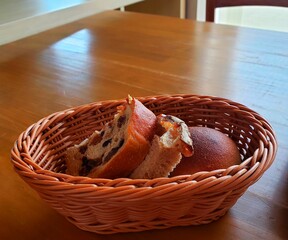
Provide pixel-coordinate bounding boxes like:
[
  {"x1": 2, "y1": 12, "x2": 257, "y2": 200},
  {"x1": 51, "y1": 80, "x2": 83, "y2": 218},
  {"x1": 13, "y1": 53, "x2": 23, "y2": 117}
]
[{"x1": 0, "y1": 11, "x2": 288, "y2": 240}]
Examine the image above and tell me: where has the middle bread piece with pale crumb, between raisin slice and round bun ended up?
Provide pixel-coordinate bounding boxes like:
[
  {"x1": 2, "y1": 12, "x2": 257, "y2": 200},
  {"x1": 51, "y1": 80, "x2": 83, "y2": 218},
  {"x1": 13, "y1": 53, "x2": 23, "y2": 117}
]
[{"x1": 130, "y1": 114, "x2": 193, "y2": 179}]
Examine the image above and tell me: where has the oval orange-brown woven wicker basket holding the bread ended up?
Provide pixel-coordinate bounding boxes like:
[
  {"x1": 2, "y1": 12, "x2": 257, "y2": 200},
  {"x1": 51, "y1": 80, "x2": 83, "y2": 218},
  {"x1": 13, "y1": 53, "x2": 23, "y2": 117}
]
[{"x1": 11, "y1": 95, "x2": 277, "y2": 234}]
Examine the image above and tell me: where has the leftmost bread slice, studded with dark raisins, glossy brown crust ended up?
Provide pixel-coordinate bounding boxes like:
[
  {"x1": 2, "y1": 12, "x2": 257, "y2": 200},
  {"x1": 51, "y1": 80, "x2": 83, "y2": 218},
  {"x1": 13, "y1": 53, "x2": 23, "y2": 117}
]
[{"x1": 66, "y1": 96, "x2": 156, "y2": 179}]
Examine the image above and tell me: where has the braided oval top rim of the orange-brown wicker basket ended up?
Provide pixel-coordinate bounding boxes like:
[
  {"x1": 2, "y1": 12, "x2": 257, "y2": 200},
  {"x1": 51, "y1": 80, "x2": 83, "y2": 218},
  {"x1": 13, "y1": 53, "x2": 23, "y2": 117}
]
[{"x1": 11, "y1": 94, "x2": 278, "y2": 188}]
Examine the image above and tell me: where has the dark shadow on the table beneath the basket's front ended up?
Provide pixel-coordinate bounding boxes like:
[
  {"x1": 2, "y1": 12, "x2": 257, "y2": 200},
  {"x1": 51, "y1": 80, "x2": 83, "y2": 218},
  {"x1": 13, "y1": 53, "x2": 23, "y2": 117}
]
[{"x1": 16, "y1": 202, "x2": 230, "y2": 240}]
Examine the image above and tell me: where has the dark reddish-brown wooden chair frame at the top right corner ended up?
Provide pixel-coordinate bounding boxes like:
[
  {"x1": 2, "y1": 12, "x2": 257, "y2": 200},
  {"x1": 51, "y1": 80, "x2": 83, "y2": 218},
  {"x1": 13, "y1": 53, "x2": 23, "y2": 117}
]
[{"x1": 206, "y1": 0, "x2": 288, "y2": 22}]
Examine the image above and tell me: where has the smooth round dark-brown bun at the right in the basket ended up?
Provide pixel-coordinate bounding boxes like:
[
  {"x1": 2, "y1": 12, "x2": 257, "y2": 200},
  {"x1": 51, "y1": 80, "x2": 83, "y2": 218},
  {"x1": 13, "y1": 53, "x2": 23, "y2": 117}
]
[{"x1": 171, "y1": 127, "x2": 241, "y2": 176}]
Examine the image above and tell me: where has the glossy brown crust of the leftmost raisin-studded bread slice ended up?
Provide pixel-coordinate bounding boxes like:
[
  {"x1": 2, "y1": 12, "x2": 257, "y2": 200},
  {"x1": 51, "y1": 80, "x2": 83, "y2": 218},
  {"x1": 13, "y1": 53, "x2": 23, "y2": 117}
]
[{"x1": 66, "y1": 96, "x2": 156, "y2": 179}]
